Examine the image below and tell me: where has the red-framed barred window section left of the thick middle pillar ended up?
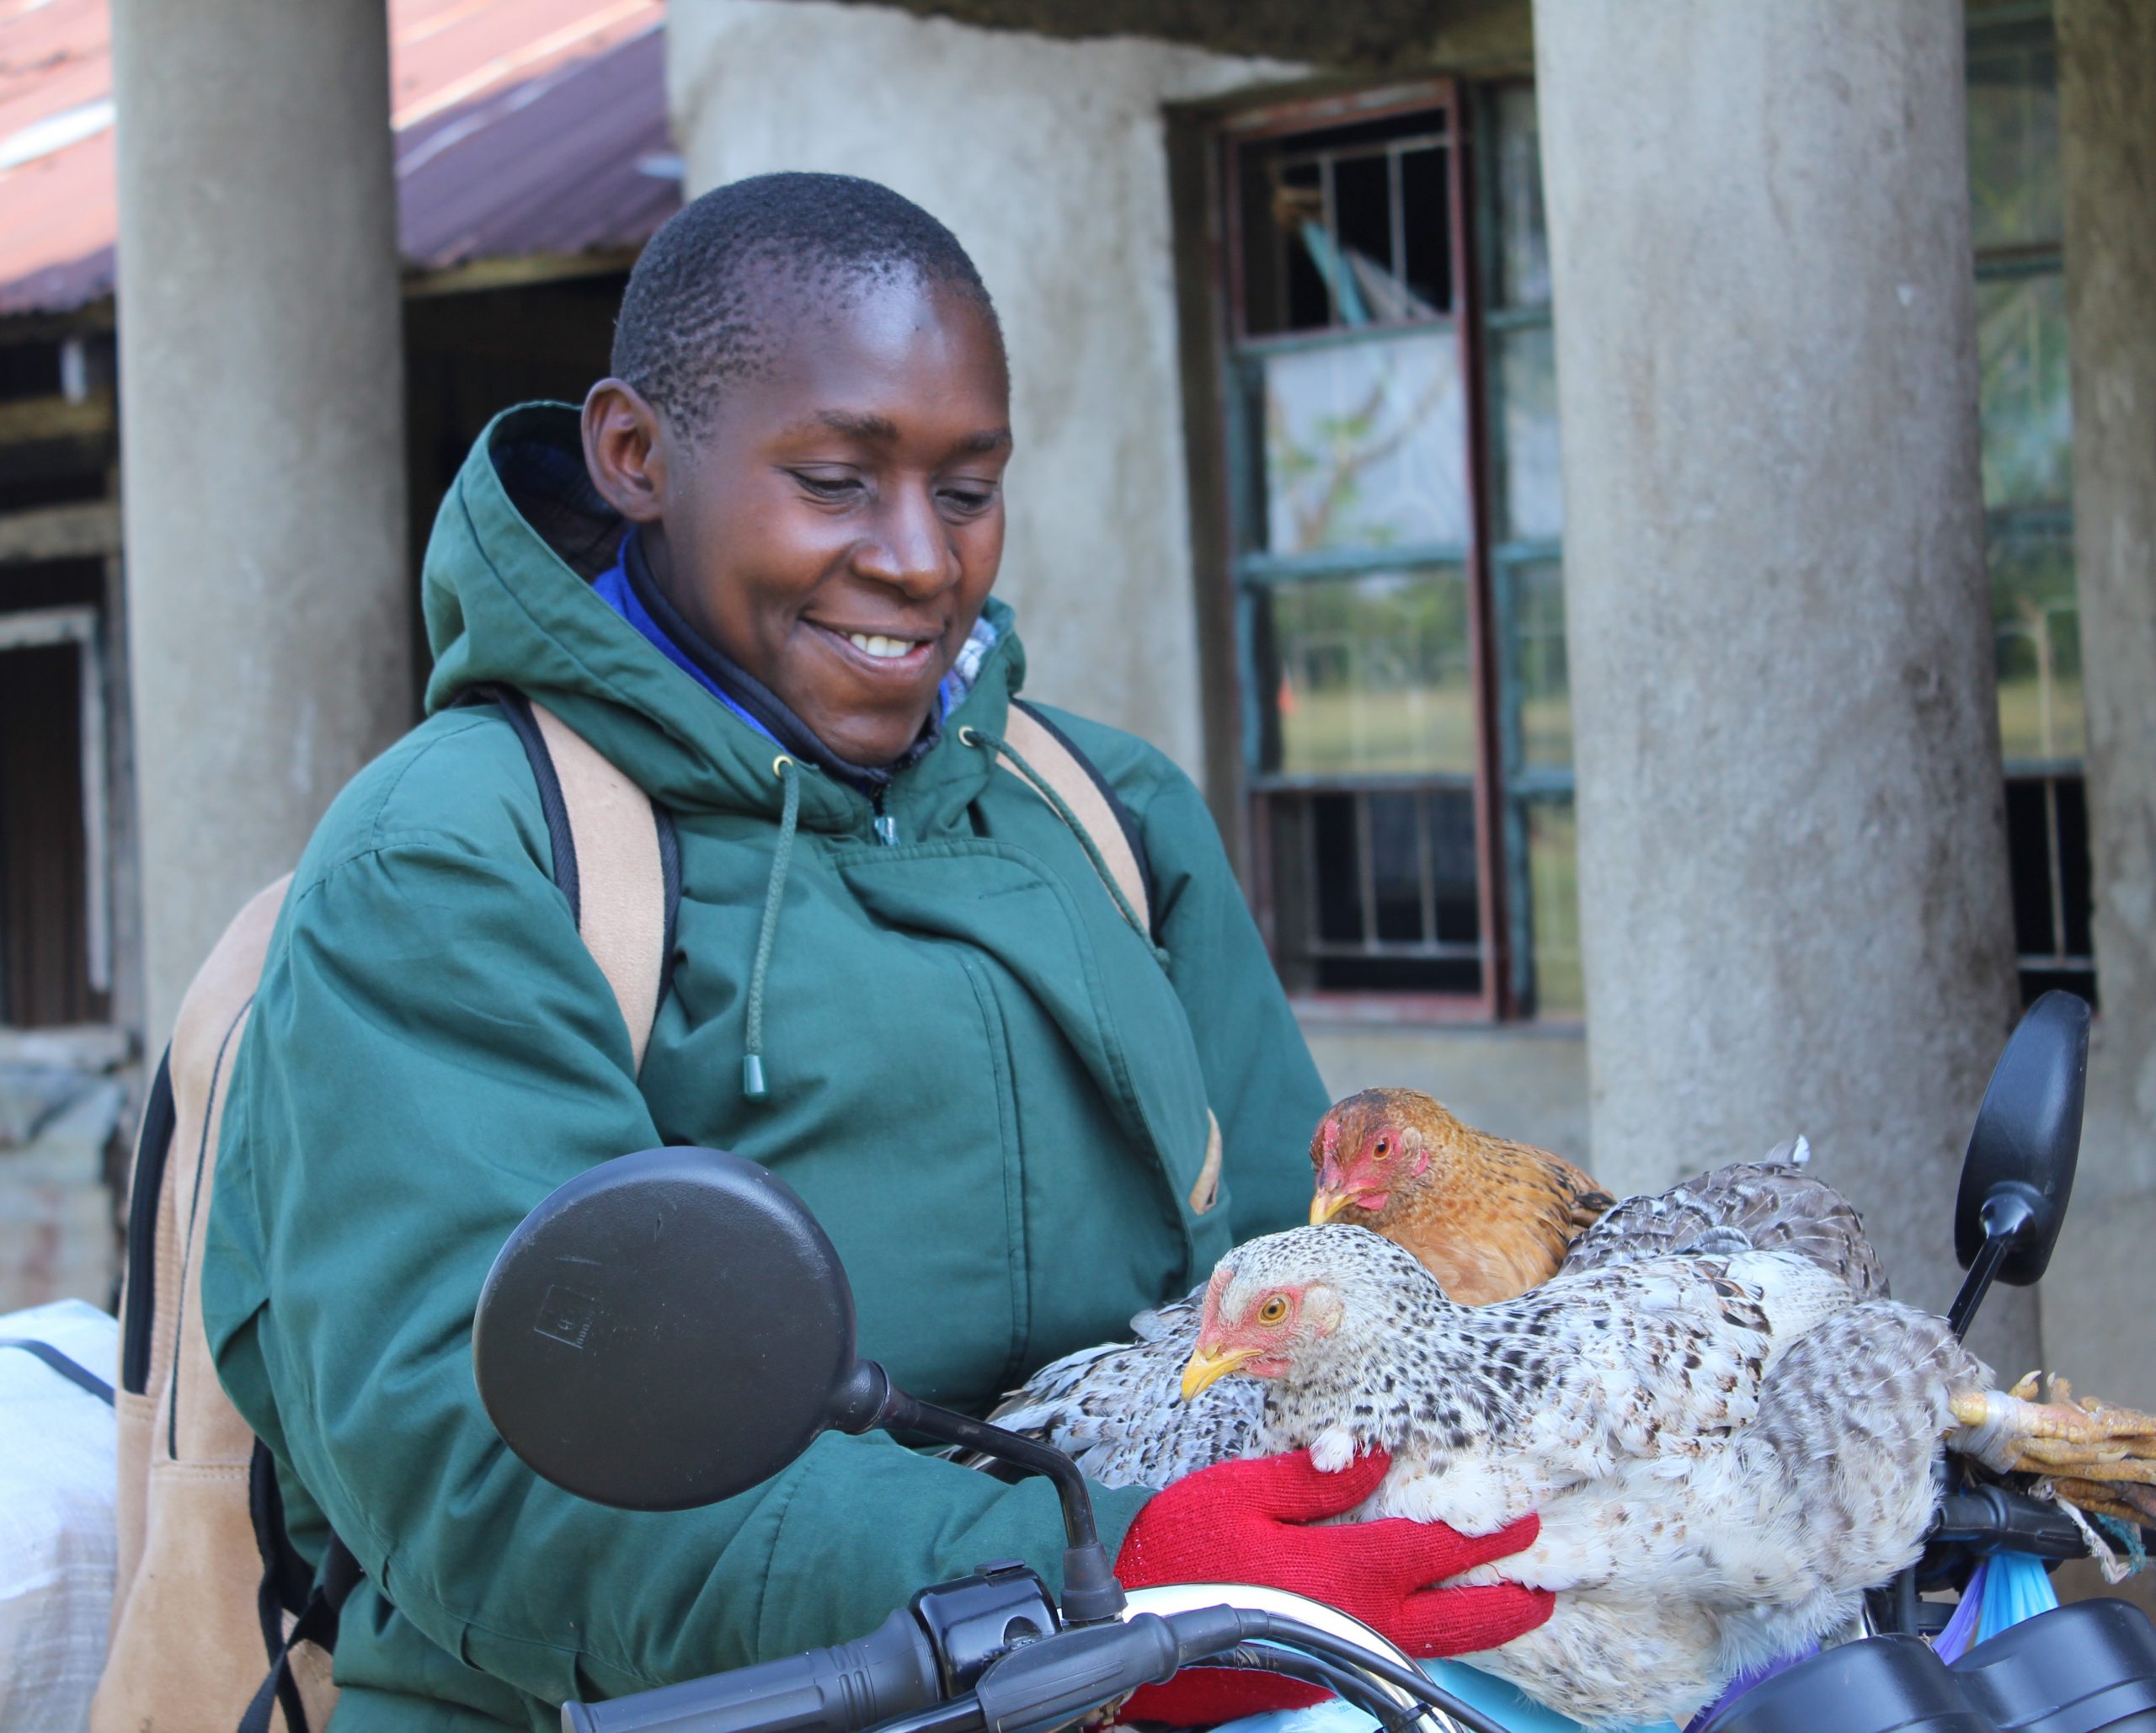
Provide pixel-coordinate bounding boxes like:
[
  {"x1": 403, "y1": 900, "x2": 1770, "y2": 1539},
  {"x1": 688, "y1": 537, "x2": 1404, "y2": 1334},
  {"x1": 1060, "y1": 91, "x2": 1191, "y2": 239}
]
[{"x1": 1220, "y1": 82, "x2": 1502, "y2": 1016}]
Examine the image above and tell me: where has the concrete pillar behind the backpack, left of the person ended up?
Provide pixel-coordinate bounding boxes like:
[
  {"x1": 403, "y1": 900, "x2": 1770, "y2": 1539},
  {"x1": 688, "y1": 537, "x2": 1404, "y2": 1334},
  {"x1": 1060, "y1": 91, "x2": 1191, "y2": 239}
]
[{"x1": 112, "y1": 0, "x2": 412, "y2": 1052}]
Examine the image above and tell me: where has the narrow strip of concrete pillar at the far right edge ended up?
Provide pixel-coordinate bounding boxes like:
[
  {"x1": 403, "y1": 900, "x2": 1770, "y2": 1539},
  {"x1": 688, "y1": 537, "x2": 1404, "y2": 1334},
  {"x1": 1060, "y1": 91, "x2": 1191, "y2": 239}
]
[{"x1": 2044, "y1": 0, "x2": 2156, "y2": 1399}]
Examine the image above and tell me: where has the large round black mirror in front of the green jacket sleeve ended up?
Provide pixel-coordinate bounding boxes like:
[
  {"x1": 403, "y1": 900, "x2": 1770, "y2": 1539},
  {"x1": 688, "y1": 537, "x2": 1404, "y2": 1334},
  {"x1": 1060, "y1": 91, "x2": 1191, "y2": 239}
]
[{"x1": 472, "y1": 1149, "x2": 858, "y2": 1511}]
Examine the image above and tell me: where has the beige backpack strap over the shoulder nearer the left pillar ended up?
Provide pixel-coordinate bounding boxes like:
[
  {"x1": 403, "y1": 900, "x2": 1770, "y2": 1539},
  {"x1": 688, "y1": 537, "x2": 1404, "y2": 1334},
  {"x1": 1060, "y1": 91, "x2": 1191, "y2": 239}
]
[{"x1": 531, "y1": 702, "x2": 670, "y2": 1071}]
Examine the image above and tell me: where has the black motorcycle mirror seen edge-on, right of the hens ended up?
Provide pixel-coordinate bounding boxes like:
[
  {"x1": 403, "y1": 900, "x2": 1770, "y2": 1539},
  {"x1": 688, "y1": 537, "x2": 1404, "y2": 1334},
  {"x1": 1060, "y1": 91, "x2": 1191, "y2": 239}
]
[{"x1": 1953, "y1": 991, "x2": 2089, "y2": 1287}]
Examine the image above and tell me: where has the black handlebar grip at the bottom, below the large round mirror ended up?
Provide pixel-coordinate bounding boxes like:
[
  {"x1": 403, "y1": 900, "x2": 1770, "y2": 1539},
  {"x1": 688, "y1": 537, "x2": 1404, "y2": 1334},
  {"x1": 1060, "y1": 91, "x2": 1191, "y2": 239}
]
[{"x1": 561, "y1": 1608, "x2": 942, "y2": 1733}]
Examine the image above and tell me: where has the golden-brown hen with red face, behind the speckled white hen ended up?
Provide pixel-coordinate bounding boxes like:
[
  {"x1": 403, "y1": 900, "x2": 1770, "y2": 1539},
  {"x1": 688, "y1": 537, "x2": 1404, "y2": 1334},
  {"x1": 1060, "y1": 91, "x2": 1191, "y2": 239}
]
[{"x1": 1310, "y1": 1089, "x2": 1614, "y2": 1306}]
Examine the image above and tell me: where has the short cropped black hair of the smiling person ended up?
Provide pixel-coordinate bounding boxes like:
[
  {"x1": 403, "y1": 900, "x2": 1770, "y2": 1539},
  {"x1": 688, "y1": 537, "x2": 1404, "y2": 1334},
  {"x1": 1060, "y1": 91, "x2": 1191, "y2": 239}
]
[{"x1": 612, "y1": 174, "x2": 996, "y2": 442}]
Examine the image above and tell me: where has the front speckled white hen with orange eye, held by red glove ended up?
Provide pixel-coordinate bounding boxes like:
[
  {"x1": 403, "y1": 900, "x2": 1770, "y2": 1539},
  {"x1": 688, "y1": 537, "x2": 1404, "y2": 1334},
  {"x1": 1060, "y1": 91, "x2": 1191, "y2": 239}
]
[{"x1": 1183, "y1": 1226, "x2": 1983, "y2": 1725}]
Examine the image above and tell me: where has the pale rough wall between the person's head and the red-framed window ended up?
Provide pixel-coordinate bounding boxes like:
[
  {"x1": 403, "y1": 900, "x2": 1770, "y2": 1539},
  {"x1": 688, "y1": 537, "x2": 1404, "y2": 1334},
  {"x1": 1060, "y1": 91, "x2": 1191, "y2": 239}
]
[{"x1": 666, "y1": 0, "x2": 1291, "y2": 776}]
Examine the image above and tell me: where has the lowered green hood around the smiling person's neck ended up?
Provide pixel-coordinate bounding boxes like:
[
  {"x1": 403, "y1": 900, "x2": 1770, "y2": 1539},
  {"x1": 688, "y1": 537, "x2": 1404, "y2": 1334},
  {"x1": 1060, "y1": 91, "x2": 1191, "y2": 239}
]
[{"x1": 420, "y1": 403, "x2": 1024, "y2": 836}]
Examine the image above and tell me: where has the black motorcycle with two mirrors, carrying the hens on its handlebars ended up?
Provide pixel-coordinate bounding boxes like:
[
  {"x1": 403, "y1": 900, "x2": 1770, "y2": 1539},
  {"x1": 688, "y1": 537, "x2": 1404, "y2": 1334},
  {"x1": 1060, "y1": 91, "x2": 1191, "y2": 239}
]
[{"x1": 472, "y1": 994, "x2": 2156, "y2": 1733}]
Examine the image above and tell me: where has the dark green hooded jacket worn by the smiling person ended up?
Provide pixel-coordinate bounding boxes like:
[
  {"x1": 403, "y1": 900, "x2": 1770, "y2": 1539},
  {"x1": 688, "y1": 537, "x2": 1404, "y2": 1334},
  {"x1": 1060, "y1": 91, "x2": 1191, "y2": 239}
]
[{"x1": 203, "y1": 405, "x2": 1326, "y2": 1733}]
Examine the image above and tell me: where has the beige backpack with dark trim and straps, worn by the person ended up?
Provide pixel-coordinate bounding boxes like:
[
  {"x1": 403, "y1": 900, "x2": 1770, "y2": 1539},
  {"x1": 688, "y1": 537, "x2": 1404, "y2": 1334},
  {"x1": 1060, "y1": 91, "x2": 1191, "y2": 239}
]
[{"x1": 91, "y1": 688, "x2": 1146, "y2": 1733}]
